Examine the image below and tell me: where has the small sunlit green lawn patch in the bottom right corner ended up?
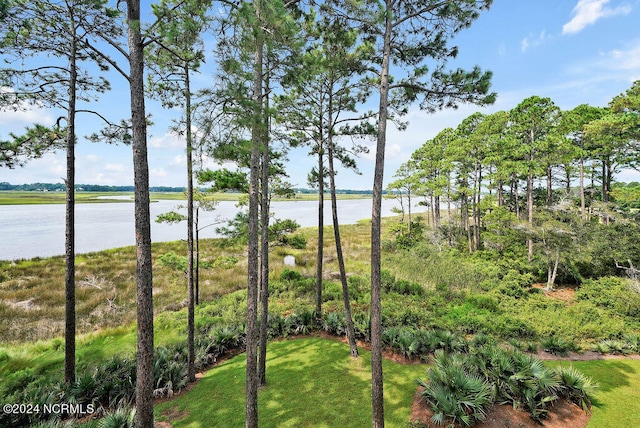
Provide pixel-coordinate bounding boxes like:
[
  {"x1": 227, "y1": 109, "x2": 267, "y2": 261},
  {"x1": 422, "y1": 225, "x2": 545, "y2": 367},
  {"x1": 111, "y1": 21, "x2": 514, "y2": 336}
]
[{"x1": 545, "y1": 359, "x2": 640, "y2": 428}]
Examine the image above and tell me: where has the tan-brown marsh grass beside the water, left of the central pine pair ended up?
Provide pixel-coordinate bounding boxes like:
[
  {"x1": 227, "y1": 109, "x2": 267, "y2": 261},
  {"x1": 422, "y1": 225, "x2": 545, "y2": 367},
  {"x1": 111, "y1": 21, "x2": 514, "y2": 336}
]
[{"x1": 0, "y1": 240, "x2": 246, "y2": 345}]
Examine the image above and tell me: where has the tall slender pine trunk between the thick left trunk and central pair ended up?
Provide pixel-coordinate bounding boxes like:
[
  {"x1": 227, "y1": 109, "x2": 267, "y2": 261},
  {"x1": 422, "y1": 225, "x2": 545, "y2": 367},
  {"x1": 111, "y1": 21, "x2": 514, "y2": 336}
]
[{"x1": 184, "y1": 66, "x2": 196, "y2": 382}]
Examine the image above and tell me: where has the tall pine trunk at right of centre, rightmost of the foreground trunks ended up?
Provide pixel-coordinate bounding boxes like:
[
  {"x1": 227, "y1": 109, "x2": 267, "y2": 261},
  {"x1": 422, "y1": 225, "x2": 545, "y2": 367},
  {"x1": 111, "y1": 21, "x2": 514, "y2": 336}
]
[{"x1": 370, "y1": 0, "x2": 392, "y2": 428}]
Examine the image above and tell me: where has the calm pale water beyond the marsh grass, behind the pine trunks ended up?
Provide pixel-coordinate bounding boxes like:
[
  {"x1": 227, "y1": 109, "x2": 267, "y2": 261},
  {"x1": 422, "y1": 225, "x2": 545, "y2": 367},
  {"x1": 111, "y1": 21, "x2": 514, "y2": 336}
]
[{"x1": 0, "y1": 199, "x2": 420, "y2": 260}]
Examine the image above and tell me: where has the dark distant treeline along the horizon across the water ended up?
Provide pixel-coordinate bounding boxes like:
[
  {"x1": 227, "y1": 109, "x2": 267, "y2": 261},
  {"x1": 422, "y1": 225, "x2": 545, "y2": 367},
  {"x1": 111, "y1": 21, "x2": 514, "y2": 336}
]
[{"x1": 0, "y1": 182, "x2": 372, "y2": 195}]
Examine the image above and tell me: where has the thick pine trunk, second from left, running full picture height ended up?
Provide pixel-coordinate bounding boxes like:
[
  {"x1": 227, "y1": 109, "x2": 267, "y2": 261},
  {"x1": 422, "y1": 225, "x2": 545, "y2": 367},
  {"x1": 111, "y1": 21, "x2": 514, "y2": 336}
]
[{"x1": 127, "y1": 0, "x2": 153, "y2": 428}]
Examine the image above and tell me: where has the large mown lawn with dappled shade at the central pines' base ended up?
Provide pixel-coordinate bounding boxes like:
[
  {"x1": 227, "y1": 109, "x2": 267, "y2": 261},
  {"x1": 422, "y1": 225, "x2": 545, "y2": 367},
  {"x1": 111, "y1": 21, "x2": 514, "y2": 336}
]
[{"x1": 155, "y1": 338, "x2": 426, "y2": 428}]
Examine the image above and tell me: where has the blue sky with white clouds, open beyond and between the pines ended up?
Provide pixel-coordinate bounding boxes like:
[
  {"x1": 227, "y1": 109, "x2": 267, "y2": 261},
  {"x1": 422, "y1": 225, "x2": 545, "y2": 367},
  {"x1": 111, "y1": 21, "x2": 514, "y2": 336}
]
[{"x1": 0, "y1": 0, "x2": 640, "y2": 190}]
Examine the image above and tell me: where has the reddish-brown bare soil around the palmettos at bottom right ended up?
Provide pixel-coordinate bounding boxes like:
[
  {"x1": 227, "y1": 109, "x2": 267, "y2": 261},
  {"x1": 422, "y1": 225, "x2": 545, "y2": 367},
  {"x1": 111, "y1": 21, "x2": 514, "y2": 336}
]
[{"x1": 411, "y1": 387, "x2": 590, "y2": 428}]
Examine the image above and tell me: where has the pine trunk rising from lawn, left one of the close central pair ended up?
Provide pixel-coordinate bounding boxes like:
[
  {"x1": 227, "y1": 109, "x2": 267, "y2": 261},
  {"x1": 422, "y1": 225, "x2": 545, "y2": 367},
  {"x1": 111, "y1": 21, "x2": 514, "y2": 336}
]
[{"x1": 245, "y1": 0, "x2": 264, "y2": 422}]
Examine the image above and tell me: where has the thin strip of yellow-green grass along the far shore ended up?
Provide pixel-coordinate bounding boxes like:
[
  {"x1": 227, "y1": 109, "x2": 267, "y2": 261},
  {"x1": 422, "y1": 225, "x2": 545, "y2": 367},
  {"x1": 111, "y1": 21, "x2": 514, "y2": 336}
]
[{"x1": 0, "y1": 190, "x2": 371, "y2": 205}]
